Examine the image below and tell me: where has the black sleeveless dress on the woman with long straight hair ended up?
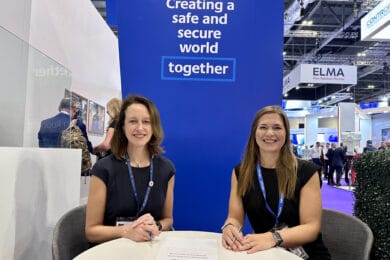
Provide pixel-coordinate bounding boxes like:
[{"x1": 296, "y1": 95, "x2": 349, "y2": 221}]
[{"x1": 235, "y1": 159, "x2": 330, "y2": 259}]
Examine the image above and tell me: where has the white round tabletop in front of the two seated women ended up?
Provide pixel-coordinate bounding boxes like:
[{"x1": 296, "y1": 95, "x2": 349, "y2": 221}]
[{"x1": 74, "y1": 231, "x2": 301, "y2": 260}]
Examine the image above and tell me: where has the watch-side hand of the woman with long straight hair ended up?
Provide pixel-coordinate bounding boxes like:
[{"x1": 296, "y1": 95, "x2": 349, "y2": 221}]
[{"x1": 240, "y1": 232, "x2": 275, "y2": 254}]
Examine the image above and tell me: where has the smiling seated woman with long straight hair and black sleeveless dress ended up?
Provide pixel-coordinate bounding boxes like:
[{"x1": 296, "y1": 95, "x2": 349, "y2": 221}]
[{"x1": 221, "y1": 106, "x2": 330, "y2": 260}]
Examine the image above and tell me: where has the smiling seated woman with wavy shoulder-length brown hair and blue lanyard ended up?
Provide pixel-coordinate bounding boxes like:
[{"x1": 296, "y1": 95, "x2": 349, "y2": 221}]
[{"x1": 85, "y1": 95, "x2": 176, "y2": 243}]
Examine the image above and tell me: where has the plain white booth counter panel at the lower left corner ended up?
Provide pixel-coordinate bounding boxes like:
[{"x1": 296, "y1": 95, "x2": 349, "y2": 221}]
[{"x1": 0, "y1": 147, "x2": 81, "y2": 260}]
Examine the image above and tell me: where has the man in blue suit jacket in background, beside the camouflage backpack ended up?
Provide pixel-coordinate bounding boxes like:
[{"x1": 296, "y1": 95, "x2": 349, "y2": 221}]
[{"x1": 38, "y1": 98, "x2": 77, "y2": 148}]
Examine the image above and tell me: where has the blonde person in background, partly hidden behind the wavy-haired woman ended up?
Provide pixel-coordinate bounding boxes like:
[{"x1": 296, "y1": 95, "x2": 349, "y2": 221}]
[{"x1": 93, "y1": 98, "x2": 122, "y2": 159}]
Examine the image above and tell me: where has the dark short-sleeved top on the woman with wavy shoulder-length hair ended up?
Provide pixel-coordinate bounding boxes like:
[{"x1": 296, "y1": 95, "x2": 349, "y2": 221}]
[{"x1": 92, "y1": 155, "x2": 176, "y2": 226}]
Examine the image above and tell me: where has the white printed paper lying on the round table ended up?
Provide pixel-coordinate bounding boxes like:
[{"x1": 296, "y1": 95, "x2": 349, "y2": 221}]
[{"x1": 157, "y1": 237, "x2": 218, "y2": 260}]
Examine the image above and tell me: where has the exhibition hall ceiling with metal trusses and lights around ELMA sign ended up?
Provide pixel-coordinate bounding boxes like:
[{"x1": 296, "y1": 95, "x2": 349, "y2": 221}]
[{"x1": 92, "y1": 0, "x2": 390, "y2": 107}]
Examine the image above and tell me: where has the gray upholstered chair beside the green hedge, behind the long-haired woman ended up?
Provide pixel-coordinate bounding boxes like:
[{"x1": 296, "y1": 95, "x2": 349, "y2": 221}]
[{"x1": 321, "y1": 209, "x2": 374, "y2": 260}]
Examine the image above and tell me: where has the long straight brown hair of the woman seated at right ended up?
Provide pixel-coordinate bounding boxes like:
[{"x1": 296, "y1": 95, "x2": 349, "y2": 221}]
[{"x1": 237, "y1": 106, "x2": 298, "y2": 198}]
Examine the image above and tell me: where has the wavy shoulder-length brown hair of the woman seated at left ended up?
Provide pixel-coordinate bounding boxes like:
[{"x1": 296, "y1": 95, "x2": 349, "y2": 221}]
[{"x1": 111, "y1": 95, "x2": 164, "y2": 159}]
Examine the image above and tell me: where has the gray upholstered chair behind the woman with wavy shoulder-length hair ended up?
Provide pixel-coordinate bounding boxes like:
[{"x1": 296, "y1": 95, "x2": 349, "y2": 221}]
[{"x1": 52, "y1": 205, "x2": 89, "y2": 260}]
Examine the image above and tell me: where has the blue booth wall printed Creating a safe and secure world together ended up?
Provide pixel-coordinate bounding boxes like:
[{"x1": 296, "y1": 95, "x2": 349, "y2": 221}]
[{"x1": 117, "y1": 0, "x2": 283, "y2": 232}]
